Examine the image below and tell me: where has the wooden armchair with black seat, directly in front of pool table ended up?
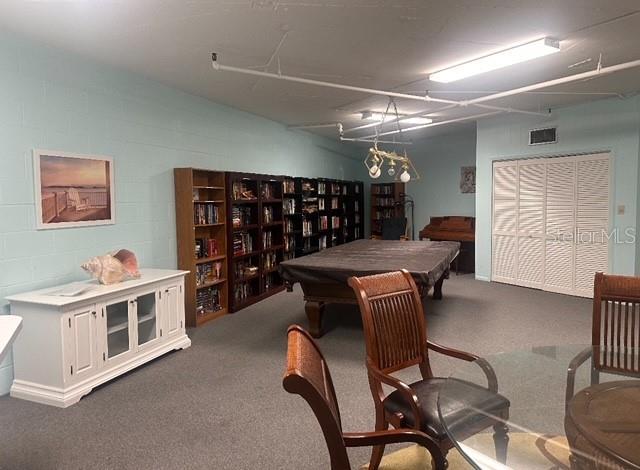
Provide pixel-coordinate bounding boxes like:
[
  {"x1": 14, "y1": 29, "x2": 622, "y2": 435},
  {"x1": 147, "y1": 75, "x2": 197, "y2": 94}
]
[{"x1": 349, "y1": 270, "x2": 509, "y2": 470}]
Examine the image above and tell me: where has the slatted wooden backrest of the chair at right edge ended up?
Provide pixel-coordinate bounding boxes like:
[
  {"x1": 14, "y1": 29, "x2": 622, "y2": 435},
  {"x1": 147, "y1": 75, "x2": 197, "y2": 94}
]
[{"x1": 592, "y1": 273, "x2": 640, "y2": 375}]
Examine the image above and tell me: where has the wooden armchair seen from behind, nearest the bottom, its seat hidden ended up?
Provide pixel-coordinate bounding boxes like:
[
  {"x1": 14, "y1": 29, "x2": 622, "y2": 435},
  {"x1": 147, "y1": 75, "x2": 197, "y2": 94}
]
[{"x1": 282, "y1": 325, "x2": 445, "y2": 470}]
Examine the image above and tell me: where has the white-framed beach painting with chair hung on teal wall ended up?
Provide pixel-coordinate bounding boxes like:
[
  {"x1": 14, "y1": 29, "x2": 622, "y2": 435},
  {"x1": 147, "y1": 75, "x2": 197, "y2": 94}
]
[{"x1": 33, "y1": 150, "x2": 115, "y2": 230}]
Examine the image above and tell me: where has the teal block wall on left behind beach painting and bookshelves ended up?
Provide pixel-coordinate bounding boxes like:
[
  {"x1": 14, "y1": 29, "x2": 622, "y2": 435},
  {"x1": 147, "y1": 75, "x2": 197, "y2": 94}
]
[{"x1": 0, "y1": 34, "x2": 361, "y2": 394}]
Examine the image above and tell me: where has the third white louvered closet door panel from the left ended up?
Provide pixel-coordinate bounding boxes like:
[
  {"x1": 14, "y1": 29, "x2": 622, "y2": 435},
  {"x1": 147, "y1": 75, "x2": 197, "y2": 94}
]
[{"x1": 543, "y1": 157, "x2": 576, "y2": 294}]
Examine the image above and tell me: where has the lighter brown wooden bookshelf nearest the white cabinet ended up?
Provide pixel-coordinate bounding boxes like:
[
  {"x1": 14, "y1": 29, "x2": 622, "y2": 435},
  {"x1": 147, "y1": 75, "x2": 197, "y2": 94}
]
[{"x1": 174, "y1": 168, "x2": 228, "y2": 327}]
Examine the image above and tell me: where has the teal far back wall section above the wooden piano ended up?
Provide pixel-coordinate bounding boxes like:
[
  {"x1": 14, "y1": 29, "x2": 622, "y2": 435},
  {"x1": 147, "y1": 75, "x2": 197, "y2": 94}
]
[{"x1": 407, "y1": 129, "x2": 476, "y2": 233}]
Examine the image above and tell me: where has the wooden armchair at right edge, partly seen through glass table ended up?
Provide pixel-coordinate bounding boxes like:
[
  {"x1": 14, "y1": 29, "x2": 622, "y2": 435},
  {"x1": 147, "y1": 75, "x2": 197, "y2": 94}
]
[{"x1": 565, "y1": 273, "x2": 640, "y2": 470}]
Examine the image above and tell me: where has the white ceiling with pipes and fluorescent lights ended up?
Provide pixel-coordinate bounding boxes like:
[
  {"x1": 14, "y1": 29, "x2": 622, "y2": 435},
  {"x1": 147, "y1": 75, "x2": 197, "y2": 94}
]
[{"x1": 0, "y1": 0, "x2": 640, "y2": 139}]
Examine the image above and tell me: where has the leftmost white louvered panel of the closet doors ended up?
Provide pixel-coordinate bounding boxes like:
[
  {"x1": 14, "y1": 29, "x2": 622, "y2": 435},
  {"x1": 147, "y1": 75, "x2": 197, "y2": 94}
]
[{"x1": 491, "y1": 162, "x2": 518, "y2": 284}]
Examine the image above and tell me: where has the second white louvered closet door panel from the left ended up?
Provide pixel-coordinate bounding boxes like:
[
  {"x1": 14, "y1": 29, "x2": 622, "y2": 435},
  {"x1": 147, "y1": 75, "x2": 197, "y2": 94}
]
[{"x1": 516, "y1": 160, "x2": 546, "y2": 289}]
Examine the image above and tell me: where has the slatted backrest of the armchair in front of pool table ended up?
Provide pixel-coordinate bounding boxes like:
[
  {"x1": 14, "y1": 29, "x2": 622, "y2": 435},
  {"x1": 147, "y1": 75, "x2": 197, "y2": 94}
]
[{"x1": 349, "y1": 270, "x2": 427, "y2": 373}]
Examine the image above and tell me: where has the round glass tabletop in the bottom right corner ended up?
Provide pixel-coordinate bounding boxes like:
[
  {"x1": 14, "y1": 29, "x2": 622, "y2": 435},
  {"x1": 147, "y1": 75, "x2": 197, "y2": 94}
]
[{"x1": 438, "y1": 345, "x2": 640, "y2": 470}]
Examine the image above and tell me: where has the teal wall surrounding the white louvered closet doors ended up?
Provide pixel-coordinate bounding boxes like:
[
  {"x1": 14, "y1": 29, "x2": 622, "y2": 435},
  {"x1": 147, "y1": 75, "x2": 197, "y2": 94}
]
[{"x1": 476, "y1": 97, "x2": 640, "y2": 280}]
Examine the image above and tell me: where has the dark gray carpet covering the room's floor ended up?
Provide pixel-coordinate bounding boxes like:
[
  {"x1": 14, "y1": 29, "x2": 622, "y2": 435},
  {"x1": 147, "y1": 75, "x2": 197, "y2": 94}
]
[{"x1": 0, "y1": 276, "x2": 591, "y2": 470}]
